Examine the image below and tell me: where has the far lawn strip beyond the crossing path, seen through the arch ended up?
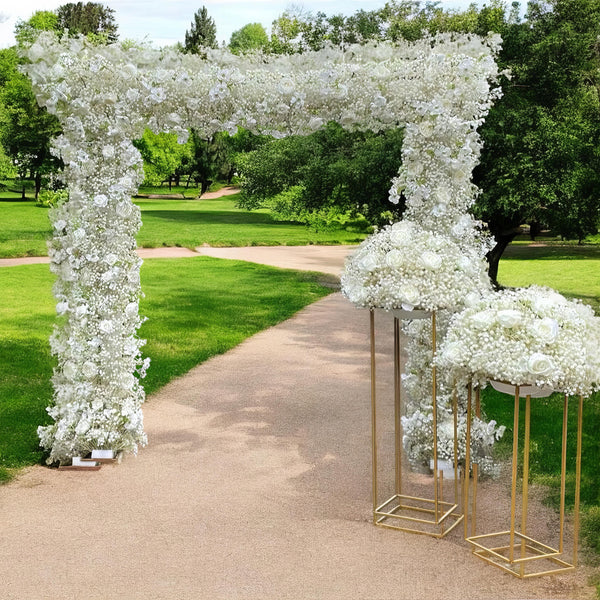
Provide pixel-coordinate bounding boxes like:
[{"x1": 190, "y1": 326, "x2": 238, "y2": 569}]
[{"x1": 0, "y1": 196, "x2": 365, "y2": 258}]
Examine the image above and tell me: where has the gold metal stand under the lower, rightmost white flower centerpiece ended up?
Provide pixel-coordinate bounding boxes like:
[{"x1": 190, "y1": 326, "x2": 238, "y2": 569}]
[{"x1": 465, "y1": 384, "x2": 583, "y2": 578}]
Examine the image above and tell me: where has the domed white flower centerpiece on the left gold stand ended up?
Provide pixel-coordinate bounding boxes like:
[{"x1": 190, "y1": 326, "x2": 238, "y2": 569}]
[{"x1": 342, "y1": 220, "x2": 490, "y2": 311}]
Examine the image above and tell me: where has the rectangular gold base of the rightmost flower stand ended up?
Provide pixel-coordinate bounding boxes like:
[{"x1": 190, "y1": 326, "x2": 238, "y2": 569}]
[{"x1": 467, "y1": 531, "x2": 575, "y2": 579}]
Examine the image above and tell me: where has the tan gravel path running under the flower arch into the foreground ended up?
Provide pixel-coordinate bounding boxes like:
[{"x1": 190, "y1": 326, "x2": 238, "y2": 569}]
[{"x1": 0, "y1": 247, "x2": 593, "y2": 600}]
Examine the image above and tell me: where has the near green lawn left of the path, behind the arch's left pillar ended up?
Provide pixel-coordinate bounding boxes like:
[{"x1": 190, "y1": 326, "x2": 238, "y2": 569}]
[{"x1": 0, "y1": 257, "x2": 331, "y2": 481}]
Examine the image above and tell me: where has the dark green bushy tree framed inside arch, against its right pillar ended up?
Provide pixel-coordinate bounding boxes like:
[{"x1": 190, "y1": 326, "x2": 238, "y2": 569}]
[{"x1": 239, "y1": 123, "x2": 403, "y2": 224}]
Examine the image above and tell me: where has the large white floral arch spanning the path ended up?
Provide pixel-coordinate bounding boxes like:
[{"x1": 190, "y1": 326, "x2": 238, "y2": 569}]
[{"x1": 26, "y1": 34, "x2": 500, "y2": 463}]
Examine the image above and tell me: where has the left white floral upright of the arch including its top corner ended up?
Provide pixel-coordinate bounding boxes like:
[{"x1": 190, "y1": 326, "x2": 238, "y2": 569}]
[{"x1": 30, "y1": 41, "x2": 149, "y2": 464}]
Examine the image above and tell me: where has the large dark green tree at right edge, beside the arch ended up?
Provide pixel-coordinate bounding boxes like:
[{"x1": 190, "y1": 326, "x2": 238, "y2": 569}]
[{"x1": 475, "y1": 0, "x2": 600, "y2": 281}]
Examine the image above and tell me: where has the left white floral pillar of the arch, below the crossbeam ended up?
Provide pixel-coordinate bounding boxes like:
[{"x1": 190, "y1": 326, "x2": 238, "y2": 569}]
[{"x1": 38, "y1": 130, "x2": 148, "y2": 462}]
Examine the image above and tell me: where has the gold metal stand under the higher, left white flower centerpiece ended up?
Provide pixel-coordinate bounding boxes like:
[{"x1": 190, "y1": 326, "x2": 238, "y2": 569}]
[{"x1": 370, "y1": 309, "x2": 463, "y2": 538}]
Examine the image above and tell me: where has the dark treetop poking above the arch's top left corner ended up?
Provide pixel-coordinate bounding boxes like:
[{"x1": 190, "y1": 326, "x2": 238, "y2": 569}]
[{"x1": 56, "y1": 2, "x2": 119, "y2": 43}]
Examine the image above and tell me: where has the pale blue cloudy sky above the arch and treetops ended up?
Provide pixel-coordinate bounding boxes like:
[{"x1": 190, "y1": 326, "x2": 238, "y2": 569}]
[{"x1": 0, "y1": 0, "x2": 502, "y2": 48}]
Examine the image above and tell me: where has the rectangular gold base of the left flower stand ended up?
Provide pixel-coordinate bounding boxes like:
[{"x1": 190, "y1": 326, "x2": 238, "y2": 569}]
[{"x1": 373, "y1": 494, "x2": 464, "y2": 538}]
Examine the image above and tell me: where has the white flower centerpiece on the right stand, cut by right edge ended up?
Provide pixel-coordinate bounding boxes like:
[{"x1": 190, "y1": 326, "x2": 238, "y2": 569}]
[{"x1": 437, "y1": 286, "x2": 600, "y2": 396}]
